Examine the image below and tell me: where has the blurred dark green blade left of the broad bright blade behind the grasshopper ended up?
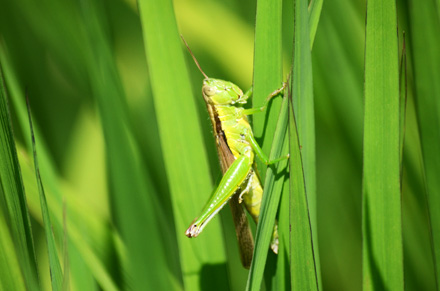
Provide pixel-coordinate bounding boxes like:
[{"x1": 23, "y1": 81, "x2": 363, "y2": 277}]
[{"x1": 82, "y1": 1, "x2": 175, "y2": 290}]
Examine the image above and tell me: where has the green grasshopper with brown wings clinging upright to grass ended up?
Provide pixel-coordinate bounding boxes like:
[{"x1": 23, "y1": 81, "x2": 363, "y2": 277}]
[{"x1": 182, "y1": 37, "x2": 289, "y2": 267}]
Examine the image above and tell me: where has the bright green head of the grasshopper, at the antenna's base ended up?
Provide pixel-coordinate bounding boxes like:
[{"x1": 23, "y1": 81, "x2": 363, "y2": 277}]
[{"x1": 202, "y1": 78, "x2": 247, "y2": 105}]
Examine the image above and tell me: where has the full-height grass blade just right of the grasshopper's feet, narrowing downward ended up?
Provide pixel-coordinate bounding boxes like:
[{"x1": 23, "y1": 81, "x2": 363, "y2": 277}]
[{"x1": 290, "y1": 0, "x2": 321, "y2": 289}]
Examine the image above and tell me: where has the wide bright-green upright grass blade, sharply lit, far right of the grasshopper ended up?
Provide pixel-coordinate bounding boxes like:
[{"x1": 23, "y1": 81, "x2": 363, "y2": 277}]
[{"x1": 362, "y1": 0, "x2": 403, "y2": 290}]
